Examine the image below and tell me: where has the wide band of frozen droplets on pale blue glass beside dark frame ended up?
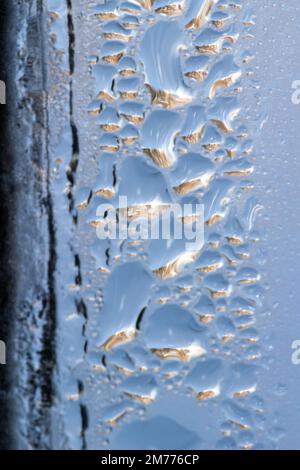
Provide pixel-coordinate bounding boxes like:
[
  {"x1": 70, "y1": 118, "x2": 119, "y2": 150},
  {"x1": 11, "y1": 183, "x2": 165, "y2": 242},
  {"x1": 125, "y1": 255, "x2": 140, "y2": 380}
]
[{"x1": 40, "y1": 0, "x2": 296, "y2": 449}]
